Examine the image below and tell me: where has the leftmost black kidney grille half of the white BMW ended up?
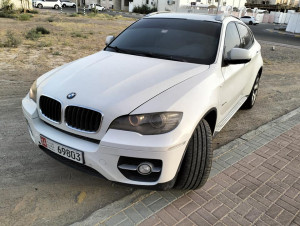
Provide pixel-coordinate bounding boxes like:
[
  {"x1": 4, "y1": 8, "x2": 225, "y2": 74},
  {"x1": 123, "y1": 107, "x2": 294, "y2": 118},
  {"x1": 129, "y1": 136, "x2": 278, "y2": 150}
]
[{"x1": 40, "y1": 96, "x2": 61, "y2": 122}]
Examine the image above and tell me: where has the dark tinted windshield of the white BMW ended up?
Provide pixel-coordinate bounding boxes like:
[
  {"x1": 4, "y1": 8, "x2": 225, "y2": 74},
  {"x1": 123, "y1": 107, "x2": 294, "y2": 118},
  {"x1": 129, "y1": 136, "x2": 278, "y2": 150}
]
[{"x1": 105, "y1": 18, "x2": 221, "y2": 64}]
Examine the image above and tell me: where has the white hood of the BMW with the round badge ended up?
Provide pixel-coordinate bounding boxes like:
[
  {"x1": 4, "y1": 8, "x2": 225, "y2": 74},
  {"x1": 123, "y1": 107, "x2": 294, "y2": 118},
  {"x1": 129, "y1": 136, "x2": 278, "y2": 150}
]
[{"x1": 38, "y1": 51, "x2": 209, "y2": 122}]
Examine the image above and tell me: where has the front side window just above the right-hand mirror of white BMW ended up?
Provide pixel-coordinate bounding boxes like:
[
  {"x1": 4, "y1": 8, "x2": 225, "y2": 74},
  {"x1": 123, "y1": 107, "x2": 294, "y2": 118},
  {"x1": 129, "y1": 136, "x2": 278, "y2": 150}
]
[{"x1": 224, "y1": 22, "x2": 241, "y2": 58}]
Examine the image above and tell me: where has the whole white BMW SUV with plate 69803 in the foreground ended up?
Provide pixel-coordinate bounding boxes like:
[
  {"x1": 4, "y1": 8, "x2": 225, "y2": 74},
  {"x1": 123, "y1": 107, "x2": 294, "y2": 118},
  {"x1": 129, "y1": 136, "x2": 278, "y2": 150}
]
[{"x1": 22, "y1": 13, "x2": 263, "y2": 189}]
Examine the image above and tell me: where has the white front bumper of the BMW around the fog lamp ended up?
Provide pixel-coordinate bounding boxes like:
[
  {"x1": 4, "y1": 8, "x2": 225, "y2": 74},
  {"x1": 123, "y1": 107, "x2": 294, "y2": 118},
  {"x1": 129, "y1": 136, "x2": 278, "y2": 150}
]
[{"x1": 22, "y1": 95, "x2": 187, "y2": 186}]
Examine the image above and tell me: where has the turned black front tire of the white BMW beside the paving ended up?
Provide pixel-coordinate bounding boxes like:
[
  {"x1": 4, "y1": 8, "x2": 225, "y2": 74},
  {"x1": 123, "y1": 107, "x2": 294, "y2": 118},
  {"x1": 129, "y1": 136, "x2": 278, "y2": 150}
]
[{"x1": 175, "y1": 119, "x2": 213, "y2": 190}]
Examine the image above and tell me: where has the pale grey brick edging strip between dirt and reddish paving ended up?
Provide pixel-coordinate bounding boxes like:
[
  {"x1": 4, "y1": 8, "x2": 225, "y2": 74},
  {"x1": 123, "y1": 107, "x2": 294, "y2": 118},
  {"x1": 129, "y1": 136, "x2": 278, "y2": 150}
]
[{"x1": 73, "y1": 107, "x2": 300, "y2": 226}]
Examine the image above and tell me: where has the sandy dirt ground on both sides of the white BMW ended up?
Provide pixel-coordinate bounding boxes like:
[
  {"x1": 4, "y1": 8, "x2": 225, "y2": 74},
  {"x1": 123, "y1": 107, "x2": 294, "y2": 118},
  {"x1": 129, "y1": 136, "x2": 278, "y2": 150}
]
[{"x1": 0, "y1": 14, "x2": 300, "y2": 225}]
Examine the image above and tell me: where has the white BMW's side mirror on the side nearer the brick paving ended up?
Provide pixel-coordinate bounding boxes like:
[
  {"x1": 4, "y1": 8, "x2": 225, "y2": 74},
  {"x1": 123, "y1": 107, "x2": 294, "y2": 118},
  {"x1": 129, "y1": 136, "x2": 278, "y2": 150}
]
[{"x1": 224, "y1": 48, "x2": 251, "y2": 64}]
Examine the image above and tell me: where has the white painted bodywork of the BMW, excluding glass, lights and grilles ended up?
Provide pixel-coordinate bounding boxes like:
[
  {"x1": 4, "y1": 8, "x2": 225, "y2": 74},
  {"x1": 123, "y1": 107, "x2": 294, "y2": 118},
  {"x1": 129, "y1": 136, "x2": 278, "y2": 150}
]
[{"x1": 22, "y1": 13, "x2": 263, "y2": 186}]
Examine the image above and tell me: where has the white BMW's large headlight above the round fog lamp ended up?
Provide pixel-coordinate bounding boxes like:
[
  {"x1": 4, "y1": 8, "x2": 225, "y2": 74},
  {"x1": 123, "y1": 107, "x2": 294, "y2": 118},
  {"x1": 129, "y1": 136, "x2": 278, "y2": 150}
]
[{"x1": 109, "y1": 112, "x2": 182, "y2": 135}]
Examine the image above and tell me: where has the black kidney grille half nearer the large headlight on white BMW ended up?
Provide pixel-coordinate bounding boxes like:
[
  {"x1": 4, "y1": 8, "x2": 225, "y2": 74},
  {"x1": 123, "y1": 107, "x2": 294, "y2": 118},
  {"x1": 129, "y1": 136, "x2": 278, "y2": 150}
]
[{"x1": 65, "y1": 106, "x2": 102, "y2": 132}]
